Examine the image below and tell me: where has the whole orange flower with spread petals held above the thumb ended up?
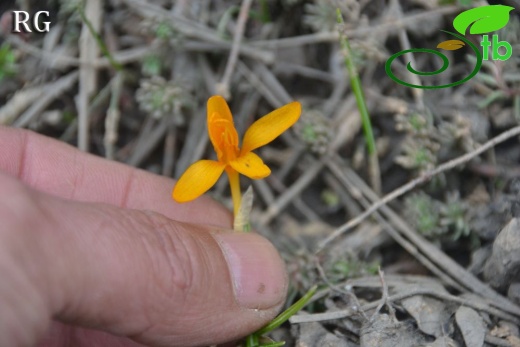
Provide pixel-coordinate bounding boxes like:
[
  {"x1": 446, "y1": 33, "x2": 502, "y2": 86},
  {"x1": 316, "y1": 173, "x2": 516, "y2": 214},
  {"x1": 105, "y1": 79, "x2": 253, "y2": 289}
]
[{"x1": 172, "y1": 95, "x2": 301, "y2": 215}]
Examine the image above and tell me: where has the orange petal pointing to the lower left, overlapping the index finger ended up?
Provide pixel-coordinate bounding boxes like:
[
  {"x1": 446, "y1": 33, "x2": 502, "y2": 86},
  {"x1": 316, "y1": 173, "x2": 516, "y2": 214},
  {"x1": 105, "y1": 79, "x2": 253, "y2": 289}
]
[{"x1": 172, "y1": 160, "x2": 226, "y2": 202}]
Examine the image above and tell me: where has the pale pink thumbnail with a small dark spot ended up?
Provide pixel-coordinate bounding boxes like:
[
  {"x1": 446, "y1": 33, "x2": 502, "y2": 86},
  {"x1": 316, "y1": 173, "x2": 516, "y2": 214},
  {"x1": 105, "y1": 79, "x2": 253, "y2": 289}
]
[{"x1": 214, "y1": 233, "x2": 287, "y2": 309}]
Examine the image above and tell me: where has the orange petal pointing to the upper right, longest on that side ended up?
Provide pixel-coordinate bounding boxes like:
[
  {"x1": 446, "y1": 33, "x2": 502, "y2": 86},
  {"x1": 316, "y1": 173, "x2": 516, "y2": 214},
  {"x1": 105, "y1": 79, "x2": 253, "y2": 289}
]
[{"x1": 240, "y1": 101, "x2": 302, "y2": 154}]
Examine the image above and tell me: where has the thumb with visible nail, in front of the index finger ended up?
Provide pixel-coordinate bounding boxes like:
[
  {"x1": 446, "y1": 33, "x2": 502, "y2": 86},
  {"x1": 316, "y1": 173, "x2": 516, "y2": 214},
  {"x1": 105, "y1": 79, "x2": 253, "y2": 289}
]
[{"x1": 0, "y1": 175, "x2": 287, "y2": 346}]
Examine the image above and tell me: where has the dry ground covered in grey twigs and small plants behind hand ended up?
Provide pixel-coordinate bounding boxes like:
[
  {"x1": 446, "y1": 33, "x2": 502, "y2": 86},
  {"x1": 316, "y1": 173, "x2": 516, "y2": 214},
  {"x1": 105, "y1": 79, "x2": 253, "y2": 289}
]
[{"x1": 0, "y1": 0, "x2": 520, "y2": 347}]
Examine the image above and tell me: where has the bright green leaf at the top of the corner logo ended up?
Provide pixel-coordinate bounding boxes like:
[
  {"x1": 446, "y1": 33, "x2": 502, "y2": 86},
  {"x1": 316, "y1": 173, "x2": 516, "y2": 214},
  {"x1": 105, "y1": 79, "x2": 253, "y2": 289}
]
[{"x1": 453, "y1": 5, "x2": 514, "y2": 35}]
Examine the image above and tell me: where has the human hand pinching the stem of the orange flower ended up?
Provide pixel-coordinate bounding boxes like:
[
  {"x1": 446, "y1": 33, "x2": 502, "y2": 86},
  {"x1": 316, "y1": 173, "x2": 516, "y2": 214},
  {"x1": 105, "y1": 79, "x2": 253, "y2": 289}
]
[{"x1": 0, "y1": 127, "x2": 287, "y2": 347}]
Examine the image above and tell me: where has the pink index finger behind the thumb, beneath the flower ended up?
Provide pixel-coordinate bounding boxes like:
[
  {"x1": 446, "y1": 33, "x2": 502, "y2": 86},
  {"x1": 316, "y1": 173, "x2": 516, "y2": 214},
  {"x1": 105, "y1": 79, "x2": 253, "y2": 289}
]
[{"x1": 0, "y1": 126, "x2": 231, "y2": 227}]
